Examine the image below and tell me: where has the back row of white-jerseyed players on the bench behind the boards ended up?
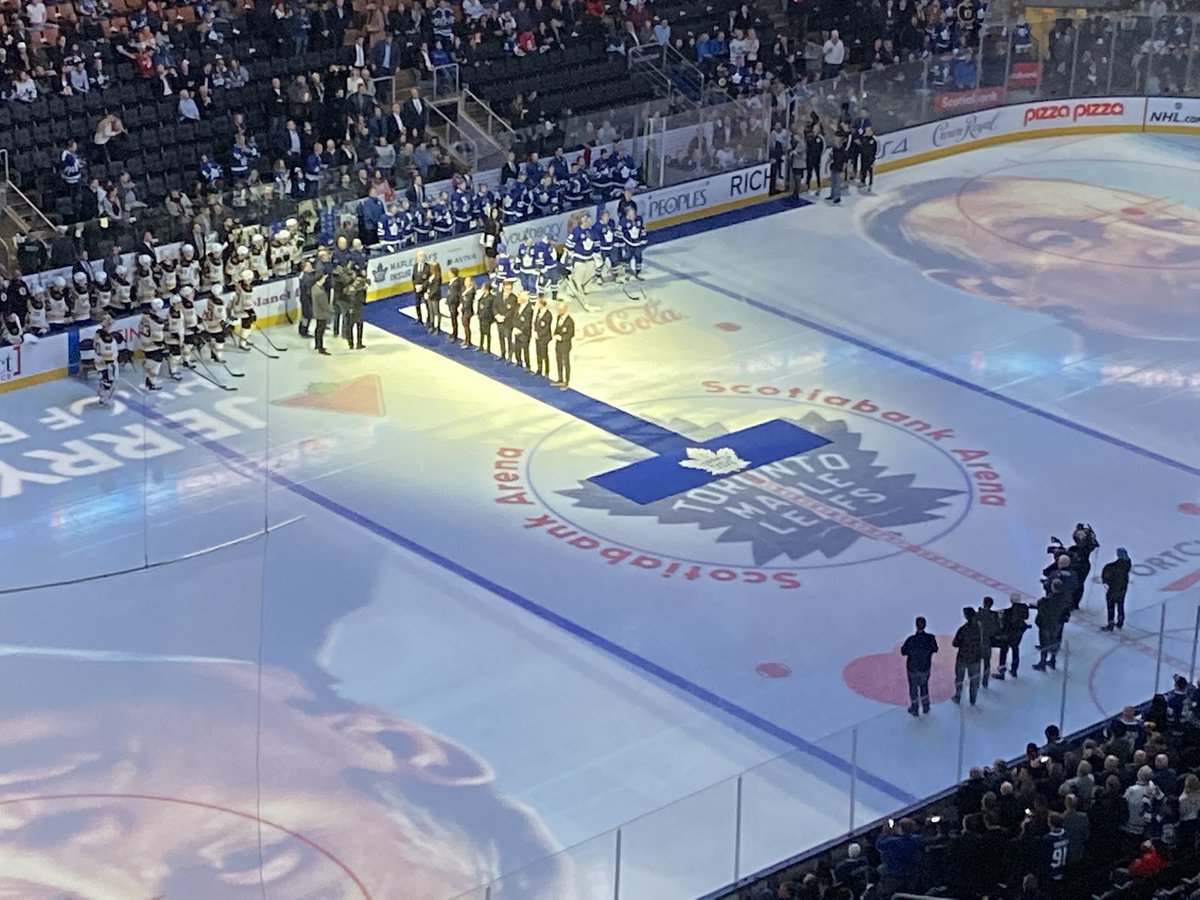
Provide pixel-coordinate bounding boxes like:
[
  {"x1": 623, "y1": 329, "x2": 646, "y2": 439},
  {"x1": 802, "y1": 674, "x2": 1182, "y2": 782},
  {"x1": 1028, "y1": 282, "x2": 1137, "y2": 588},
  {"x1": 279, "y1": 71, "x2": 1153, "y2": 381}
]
[{"x1": 17, "y1": 228, "x2": 304, "y2": 336}]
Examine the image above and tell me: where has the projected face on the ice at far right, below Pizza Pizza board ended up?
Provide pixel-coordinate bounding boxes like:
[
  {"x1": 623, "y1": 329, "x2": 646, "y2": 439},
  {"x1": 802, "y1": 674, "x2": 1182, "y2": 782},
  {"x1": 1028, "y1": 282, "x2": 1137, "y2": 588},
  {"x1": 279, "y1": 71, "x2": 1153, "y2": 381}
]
[{"x1": 864, "y1": 176, "x2": 1200, "y2": 340}]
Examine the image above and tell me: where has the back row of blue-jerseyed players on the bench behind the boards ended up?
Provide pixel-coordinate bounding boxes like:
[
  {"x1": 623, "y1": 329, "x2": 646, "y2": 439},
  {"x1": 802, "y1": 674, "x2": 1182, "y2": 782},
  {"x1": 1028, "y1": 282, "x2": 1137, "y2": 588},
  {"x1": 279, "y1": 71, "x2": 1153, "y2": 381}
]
[{"x1": 376, "y1": 161, "x2": 636, "y2": 250}]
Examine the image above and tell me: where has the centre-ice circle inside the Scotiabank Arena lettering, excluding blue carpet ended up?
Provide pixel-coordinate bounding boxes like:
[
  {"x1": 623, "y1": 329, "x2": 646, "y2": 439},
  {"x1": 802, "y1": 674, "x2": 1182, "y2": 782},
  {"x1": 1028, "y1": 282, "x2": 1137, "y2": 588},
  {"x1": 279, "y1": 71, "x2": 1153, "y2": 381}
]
[{"x1": 526, "y1": 396, "x2": 973, "y2": 570}]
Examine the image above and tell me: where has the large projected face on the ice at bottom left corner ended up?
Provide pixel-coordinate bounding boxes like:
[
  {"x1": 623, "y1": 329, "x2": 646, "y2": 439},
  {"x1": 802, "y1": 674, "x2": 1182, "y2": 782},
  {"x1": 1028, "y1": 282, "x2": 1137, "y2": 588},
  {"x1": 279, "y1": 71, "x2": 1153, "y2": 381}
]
[{"x1": 0, "y1": 658, "x2": 569, "y2": 900}]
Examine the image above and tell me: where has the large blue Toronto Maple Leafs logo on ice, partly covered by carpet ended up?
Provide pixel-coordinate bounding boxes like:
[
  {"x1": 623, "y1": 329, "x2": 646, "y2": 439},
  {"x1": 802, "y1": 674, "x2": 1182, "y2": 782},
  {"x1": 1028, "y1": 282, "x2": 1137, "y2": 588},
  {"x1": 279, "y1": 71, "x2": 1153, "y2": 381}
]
[{"x1": 559, "y1": 413, "x2": 964, "y2": 565}]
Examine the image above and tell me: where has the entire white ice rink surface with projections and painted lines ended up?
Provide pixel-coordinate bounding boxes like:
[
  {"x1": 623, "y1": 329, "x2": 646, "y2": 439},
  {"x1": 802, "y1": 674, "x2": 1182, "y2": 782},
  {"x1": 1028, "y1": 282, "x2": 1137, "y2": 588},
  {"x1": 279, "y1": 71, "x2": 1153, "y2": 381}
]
[{"x1": 0, "y1": 136, "x2": 1200, "y2": 900}]
